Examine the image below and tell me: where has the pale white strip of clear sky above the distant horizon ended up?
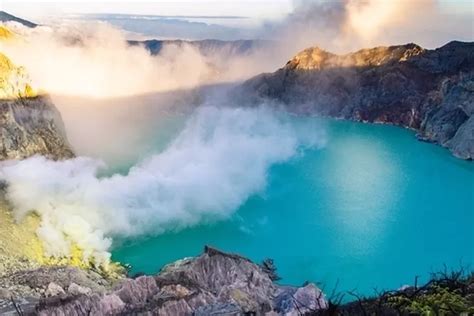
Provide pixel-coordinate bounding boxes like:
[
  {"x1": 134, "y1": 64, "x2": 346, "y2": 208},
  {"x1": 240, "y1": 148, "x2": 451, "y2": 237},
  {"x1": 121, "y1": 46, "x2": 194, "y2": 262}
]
[{"x1": 0, "y1": 0, "x2": 474, "y2": 19}]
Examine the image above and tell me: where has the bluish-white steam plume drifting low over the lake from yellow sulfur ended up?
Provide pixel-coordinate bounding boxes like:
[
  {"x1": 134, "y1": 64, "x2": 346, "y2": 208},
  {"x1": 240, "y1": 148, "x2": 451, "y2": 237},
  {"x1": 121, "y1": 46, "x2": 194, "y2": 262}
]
[{"x1": 0, "y1": 106, "x2": 324, "y2": 262}]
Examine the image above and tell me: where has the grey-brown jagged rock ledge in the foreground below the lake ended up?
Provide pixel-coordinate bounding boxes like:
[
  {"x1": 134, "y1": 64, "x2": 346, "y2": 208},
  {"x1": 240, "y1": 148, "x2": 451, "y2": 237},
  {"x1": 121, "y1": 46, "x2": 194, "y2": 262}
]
[{"x1": 0, "y1": 246, "x2": 328, "y2": 315}]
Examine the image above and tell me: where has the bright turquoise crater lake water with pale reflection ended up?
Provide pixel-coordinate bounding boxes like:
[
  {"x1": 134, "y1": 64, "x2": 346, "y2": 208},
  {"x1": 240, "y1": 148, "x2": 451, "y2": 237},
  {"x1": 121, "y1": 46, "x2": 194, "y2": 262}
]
[{"x1": 113, "y1": 115, "x2": 474, "y2": 295}]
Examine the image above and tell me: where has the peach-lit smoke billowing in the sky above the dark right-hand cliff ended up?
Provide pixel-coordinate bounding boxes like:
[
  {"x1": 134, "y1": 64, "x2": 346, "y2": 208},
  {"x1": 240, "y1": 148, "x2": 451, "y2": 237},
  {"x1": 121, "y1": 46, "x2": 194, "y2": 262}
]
[{"x1": 265, "y1": 0, "x2": 474, "y2": 56}]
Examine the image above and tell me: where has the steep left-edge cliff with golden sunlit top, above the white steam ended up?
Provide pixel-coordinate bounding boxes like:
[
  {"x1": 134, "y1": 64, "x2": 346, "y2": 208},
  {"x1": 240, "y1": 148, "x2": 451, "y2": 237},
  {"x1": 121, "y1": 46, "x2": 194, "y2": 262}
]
[{"x1": 0, "y1": 54, "x2": 74, "y2": 160}]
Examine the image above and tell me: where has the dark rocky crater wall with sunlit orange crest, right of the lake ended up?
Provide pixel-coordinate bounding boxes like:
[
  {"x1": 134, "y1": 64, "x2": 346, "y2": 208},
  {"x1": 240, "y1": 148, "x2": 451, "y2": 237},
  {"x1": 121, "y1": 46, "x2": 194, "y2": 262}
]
[{"x1": 242, "y1": 42, "x2": 474, "y2": 159}]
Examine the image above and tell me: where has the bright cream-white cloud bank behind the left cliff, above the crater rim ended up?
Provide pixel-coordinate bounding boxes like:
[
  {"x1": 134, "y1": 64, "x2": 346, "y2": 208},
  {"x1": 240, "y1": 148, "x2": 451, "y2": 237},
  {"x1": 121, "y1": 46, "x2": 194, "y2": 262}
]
[{"x1": 0, "y1": 21, "x2": 273, "y2": 98}]
